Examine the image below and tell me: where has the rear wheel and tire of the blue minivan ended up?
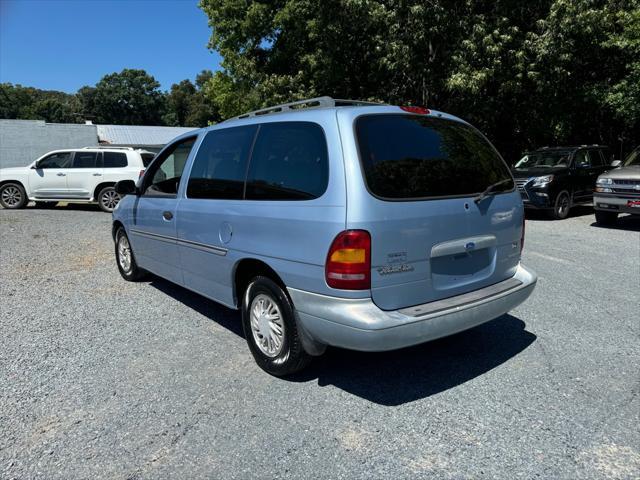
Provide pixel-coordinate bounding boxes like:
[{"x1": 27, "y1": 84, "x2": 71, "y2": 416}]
[{"x1": 242, "y1": 277, "x2": 311, "y2": 377}]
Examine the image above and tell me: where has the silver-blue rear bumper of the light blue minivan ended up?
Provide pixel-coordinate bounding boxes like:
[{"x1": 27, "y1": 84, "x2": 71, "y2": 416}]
[{"x1": 288, "y1": 265, "x2": 537, "y2": 351}]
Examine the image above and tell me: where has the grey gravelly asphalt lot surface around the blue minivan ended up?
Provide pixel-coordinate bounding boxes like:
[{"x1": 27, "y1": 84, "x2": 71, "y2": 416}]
[{"x1": 0, "y1": 207, "x2": 640, "y2": 479}]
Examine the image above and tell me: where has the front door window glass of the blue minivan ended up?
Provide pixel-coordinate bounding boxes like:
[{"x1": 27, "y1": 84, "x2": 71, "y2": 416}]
[{"x1": 143, "y1": 137, "x2": 196, "y2": 197}]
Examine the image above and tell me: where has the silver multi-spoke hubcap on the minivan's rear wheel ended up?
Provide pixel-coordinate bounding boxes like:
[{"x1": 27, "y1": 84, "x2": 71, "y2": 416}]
[{"x1": 250, "y1": 293, "x2": 284, "y2": 358}]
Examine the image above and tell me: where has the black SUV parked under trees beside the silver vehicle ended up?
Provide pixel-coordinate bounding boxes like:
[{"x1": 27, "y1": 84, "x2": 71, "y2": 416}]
[{"x1": 512, "y1": 145, "x2": 611, "y2": 220}]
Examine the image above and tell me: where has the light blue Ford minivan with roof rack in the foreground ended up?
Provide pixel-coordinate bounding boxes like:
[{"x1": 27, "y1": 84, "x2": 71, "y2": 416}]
[{"x1": 113, "y1": 97, "x2": 537, "y2": 375}]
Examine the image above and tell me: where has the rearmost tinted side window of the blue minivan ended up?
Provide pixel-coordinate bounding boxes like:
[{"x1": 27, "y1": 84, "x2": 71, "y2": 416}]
[{"x1": 246, "y1": 122, "x2": 329, "y2": 200}]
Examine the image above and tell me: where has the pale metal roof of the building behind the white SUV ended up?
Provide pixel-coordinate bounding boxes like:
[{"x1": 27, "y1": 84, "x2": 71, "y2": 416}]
[{"x1": 96, "y1": 125, "x2": 197, "y2": 146}]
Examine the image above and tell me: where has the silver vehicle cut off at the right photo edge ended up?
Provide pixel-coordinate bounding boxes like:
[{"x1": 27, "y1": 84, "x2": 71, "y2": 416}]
[{"x1": 593, "y1": 146, "x2": 640, "y2": 225}]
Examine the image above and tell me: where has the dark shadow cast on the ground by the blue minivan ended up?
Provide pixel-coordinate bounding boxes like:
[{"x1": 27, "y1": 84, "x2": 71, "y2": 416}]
[{"x1": 150, "y1": 277, "x2": 536, "y2": 406}]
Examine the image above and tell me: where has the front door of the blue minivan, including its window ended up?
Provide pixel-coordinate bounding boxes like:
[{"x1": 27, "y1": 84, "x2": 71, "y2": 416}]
[{"x1": 130, "y1": 137, "x2": 196, "y2": 285}]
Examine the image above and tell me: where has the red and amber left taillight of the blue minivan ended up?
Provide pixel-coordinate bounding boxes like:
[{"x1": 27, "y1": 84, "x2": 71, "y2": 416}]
[{"x1": 325, "y1": 230, "x2": 371, "y2": 290}]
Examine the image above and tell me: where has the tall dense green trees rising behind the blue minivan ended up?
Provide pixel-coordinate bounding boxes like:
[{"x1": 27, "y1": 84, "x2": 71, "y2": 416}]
[{"x1": 200, "y1": 0, "x2": 640, "y2": 161}]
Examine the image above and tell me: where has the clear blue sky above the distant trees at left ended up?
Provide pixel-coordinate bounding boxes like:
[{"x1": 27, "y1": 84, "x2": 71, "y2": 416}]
[{"x1": 0, "y1": 0, "x2": 220, "y2": 93}]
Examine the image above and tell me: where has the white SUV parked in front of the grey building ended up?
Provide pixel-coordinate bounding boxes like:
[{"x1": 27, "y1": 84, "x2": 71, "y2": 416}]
[{"x1": 0, "y1": 147, "x2": 155, "y2": 212}]
